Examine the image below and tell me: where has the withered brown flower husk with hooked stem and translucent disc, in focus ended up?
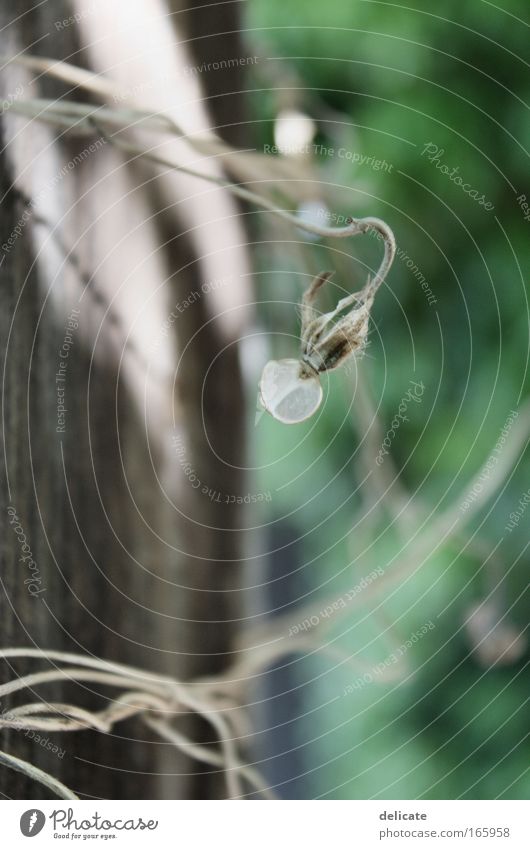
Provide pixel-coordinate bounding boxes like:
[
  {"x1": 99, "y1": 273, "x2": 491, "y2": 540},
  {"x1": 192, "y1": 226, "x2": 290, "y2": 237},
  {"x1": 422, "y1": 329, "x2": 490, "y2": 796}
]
[{"x1": 259, "y1": 218, "x2": 396, "y2": 424}]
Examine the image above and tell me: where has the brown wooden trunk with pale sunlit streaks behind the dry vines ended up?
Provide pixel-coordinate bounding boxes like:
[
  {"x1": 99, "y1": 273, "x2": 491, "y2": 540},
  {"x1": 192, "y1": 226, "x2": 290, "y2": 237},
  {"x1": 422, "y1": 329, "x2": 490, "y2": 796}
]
[{"x1": 0, "y1": 0, "x2": 247, "y2": 799}]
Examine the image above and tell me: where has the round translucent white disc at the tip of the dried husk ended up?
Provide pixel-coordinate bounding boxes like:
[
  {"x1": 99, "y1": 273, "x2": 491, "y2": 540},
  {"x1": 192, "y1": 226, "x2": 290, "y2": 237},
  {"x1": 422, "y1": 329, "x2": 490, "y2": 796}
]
[{"x1": 260, "y1": 360, "x2": 322, "y2": 424}]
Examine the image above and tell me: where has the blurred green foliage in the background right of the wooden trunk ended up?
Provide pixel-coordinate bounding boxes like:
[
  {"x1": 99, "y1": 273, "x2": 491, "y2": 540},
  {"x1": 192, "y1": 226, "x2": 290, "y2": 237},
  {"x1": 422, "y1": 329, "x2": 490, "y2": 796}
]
[{"x1": 245, "y1": 0, "x2": 530, "y2": 798}]
